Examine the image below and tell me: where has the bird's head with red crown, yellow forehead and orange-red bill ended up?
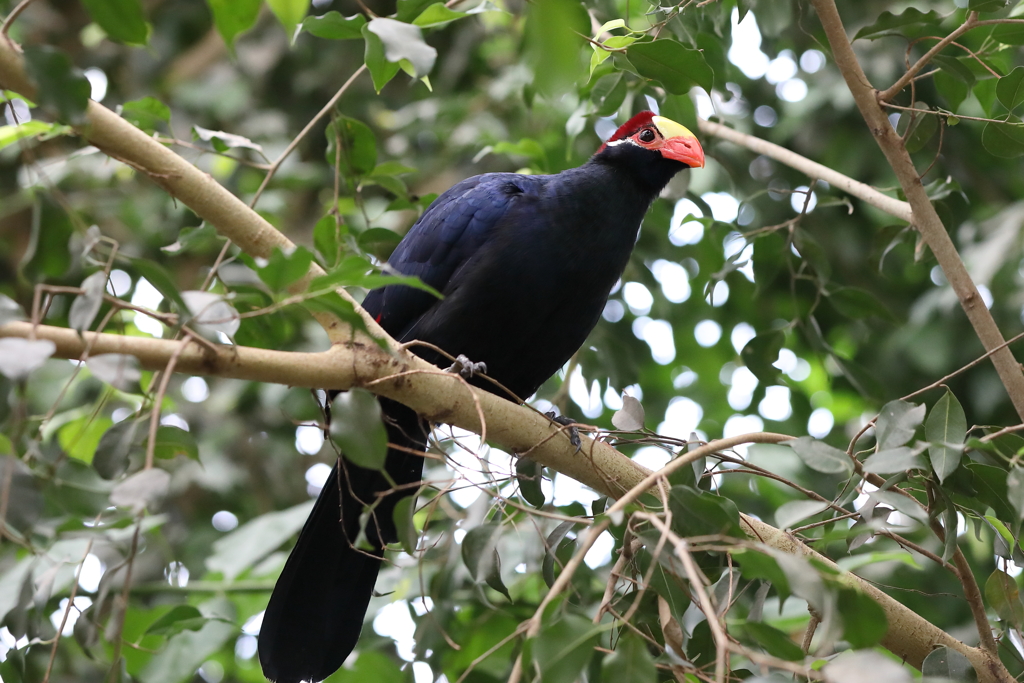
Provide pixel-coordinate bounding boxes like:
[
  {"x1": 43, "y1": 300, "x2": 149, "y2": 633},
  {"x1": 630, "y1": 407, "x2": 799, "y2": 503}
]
[{"x1": 594, "y1": 112, "x2": 705, "y2": 186}]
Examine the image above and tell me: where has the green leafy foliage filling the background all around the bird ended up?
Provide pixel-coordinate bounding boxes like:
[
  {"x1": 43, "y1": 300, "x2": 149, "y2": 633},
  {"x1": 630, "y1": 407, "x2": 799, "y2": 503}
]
[{"x1": 0, "y1": 0, "x2": 1024, "y2": 683}]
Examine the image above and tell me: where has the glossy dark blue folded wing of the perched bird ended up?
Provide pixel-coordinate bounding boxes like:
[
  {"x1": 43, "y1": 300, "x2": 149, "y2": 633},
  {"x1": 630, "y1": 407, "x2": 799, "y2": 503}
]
[{"x1": 362, "y1": 173, "x2": 540, "y2": 339}]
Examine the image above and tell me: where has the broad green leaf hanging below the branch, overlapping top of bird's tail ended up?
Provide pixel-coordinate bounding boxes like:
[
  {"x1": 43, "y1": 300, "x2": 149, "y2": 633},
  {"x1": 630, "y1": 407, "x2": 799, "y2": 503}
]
[{"x1": 331, "y1": 389, "x2": 387, "y2": 470}]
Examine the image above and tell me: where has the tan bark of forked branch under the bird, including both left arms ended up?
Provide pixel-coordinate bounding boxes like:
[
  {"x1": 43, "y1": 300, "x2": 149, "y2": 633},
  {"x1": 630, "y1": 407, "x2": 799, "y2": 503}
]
[{"x1": 0, "y1": 34, "x2": 1007, "y2": 683}]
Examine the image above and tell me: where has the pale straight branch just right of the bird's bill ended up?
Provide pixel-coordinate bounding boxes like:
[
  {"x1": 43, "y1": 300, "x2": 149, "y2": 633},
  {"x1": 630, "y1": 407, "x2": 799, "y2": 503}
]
[{"x1": 697, "y1": 119, "x2": 913, "y2": 223}]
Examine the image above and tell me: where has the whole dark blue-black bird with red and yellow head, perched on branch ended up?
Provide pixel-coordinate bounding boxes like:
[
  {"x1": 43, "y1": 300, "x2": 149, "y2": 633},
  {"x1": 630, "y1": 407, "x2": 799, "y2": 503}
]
[{"x1": 258, "y1": 111, "x2": 705, "y2": 683}]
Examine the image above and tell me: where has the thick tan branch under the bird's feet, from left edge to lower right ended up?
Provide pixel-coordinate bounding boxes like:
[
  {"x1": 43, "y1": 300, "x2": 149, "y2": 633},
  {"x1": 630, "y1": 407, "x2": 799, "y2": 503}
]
[{"x1": 0, "y1": 323, "x2": 991, "y2": 683}]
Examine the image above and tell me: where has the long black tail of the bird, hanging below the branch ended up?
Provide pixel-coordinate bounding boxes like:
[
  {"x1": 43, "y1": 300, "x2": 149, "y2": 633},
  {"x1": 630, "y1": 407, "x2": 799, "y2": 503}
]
[{"x1": 259, "y1": 399, "x2": 426, "y2": 683}]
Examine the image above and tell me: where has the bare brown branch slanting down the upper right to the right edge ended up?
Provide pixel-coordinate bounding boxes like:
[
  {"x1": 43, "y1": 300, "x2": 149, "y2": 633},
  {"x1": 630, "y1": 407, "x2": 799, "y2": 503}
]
[{"x1": 811, "y1": 0, "x2": 1024, "y2": 421}]
